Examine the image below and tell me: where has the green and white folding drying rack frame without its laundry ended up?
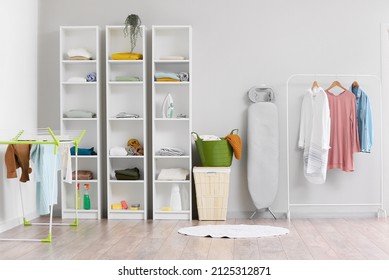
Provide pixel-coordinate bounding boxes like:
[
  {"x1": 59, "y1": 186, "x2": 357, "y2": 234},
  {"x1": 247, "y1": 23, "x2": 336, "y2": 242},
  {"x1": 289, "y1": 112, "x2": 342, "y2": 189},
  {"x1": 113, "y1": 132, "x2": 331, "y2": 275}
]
[{"x1": 0, "y1": 128, "x2": 86, "y2": 243}]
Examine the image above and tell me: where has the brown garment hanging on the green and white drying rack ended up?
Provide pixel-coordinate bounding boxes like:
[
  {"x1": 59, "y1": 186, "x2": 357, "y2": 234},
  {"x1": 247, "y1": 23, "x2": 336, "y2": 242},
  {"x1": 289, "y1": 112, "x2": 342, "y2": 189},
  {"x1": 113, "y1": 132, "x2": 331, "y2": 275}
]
[{"x1": 4, "y1": 144, "x2": 32, "y2": 183}]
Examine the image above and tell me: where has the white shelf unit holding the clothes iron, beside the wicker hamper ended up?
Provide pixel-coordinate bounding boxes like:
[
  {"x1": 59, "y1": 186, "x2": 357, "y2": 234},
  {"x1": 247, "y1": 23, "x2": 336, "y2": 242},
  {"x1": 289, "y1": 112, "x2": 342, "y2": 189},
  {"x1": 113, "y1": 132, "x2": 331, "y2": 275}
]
[{"x1": 152, "y1": 25, "x2": 192, "y2": 220}]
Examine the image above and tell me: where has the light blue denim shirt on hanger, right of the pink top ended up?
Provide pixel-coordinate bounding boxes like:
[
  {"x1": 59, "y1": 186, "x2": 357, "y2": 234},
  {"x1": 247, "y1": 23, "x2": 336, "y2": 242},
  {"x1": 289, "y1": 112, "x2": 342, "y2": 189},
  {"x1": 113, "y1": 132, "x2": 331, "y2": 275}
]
[{"x1": 350, "y1": 86, "x2": 373, "y2": 153}]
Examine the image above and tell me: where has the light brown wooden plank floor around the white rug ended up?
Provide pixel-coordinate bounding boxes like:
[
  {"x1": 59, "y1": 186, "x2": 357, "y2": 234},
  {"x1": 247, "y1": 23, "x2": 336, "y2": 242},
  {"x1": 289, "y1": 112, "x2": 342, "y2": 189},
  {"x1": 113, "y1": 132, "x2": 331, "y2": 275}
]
[{"x1": 0, "y1": 218, "x2": 389, "y2": 260}]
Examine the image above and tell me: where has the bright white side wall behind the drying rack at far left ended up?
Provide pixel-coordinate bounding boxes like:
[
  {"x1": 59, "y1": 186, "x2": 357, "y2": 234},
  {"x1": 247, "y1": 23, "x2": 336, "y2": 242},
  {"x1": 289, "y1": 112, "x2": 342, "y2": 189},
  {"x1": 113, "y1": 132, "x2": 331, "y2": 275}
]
[{"x1": 0, "y1": 0, "x2": 38, "y2": 232}]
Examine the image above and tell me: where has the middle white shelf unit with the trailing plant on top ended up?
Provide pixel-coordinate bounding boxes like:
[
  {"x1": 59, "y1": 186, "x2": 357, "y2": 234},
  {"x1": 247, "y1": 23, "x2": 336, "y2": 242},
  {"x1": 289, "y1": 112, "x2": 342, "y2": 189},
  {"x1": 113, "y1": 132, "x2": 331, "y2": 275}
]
[{"x1": 106, "y1": 25, "x2": 147, "y2": 220}]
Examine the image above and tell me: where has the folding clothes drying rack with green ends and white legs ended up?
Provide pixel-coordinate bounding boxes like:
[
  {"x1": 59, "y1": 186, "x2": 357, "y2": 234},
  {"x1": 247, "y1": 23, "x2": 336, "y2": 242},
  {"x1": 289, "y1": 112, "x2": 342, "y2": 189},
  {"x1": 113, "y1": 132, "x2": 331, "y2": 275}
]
[{"x1": 0, "y1": 128, "x2": 85, "y2": 243}]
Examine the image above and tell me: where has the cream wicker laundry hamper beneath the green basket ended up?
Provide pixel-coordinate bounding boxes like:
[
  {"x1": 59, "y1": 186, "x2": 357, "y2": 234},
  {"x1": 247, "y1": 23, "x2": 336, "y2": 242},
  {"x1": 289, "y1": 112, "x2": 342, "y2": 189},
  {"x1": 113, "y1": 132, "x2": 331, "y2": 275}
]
[{"x1": 193, "y1": 167, "x2": 230, "y2": 221}]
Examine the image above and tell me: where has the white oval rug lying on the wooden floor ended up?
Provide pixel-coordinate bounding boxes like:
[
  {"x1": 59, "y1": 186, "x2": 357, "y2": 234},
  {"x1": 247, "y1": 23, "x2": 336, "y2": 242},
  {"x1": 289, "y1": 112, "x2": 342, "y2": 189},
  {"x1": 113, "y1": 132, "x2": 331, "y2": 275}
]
[{"x1": 178, "y1": 225, "x2": 289, "y2": 238}]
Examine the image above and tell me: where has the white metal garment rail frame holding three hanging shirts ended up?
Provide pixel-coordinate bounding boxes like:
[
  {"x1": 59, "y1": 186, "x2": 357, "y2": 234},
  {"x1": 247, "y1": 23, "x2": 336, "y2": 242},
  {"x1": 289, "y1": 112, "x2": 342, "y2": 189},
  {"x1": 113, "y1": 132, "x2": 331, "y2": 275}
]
[{"x1": 286, "y1": 74, "x2": 386, "y2": 221}]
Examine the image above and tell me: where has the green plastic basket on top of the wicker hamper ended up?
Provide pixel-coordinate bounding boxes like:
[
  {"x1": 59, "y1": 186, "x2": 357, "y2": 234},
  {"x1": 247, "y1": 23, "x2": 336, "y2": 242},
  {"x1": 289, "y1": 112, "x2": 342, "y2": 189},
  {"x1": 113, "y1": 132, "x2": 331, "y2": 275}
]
[{"x1": 192, "y1": 129, "x2": 238, "y2": 167}]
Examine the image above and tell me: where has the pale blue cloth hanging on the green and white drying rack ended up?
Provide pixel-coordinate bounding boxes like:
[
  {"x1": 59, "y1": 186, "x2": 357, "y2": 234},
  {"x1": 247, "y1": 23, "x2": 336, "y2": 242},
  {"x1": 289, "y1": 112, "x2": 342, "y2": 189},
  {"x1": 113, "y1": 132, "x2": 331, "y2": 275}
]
[{"x1": 30, "y1": 144, "x2": 61, "y2": 215}]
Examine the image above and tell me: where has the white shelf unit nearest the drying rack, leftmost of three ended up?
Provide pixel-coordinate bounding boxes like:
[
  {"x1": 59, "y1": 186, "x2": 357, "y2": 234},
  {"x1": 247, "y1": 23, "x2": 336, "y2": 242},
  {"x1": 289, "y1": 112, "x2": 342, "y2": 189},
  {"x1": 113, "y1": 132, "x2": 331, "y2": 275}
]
[{"x1": 60, "y1": 26, "x2": 101, "y2": 219}]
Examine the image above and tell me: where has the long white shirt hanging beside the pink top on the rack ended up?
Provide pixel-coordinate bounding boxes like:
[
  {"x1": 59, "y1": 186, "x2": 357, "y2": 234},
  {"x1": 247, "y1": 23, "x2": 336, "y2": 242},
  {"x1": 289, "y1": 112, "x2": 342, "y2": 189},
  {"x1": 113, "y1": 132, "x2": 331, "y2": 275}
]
[{"x1": 298, "y1": 87, "x2": 331, "y2": 184}]
